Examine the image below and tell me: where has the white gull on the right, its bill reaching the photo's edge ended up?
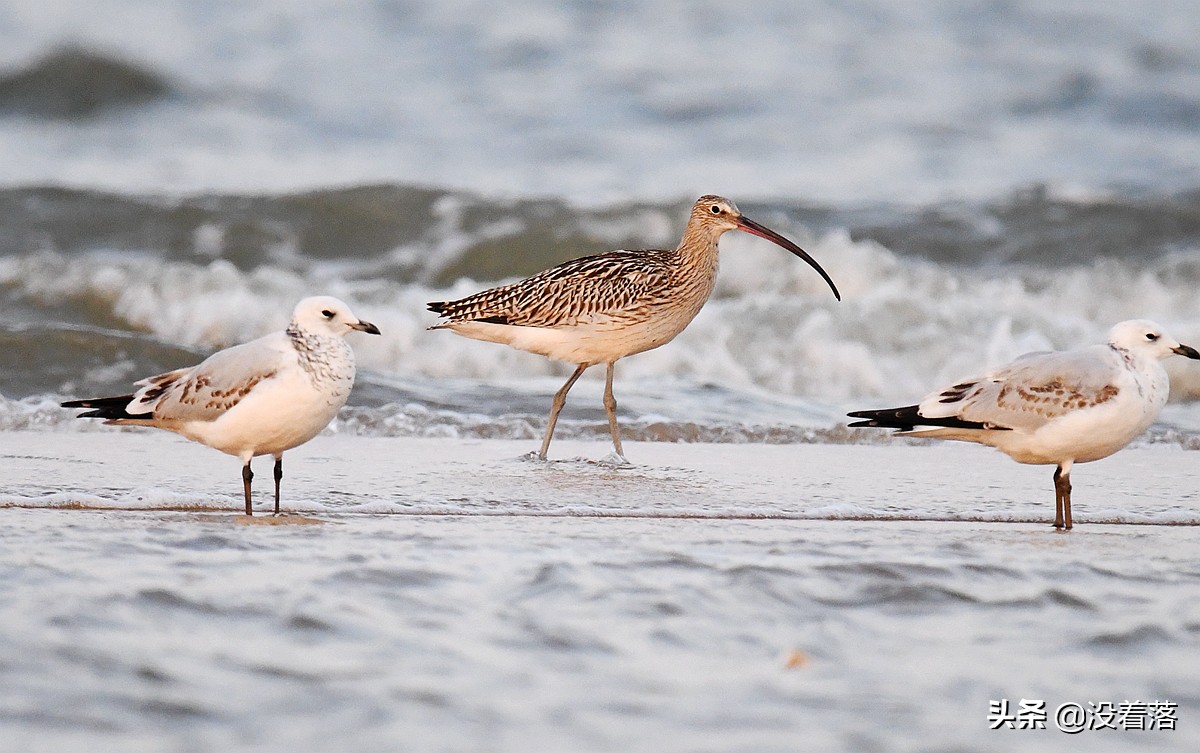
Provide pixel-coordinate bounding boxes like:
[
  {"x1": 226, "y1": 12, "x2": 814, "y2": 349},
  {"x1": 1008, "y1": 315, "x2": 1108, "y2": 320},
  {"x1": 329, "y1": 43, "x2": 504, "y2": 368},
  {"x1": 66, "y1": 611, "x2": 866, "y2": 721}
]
[{"x1": 848, "y1": 319, "x2": 1200, "y2": 530}]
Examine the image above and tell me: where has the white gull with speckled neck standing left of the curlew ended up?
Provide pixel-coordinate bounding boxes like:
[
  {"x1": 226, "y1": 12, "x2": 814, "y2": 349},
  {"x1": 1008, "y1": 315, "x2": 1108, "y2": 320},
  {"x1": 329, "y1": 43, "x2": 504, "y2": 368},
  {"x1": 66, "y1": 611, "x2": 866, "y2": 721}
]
[{"x1": 62, "y1": 296, "x2": 379, "y2": 516}]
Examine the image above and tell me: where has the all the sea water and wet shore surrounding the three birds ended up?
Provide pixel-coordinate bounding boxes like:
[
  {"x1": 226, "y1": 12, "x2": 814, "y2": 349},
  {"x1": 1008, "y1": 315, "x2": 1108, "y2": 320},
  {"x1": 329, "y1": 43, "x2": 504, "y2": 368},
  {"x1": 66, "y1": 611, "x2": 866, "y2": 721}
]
[{"x1": 0, "y1": 0, "x2": 1200, "y2": 752}]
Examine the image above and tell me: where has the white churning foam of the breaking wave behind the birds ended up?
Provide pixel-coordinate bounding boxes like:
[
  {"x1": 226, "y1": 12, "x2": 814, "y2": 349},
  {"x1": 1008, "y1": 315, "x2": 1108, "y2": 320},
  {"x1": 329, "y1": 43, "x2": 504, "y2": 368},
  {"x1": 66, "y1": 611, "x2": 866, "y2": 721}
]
[{"x1": 7, "y1": 227, "x2": 1200, "y2": 404}]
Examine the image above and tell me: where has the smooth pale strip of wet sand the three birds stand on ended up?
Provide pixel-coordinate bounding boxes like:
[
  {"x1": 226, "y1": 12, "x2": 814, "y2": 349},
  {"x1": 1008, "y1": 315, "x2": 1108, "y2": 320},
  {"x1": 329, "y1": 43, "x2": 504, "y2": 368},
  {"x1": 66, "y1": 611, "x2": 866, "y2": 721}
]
[{"x1": 0, "y1": 430, "x2": 1200, "y2": 530}]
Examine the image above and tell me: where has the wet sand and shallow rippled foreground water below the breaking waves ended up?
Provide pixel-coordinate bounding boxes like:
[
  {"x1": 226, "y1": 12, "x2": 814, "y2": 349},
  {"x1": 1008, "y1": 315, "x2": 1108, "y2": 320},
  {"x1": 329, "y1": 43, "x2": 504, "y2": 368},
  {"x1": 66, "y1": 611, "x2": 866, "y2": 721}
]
[{"x1": 0, "y1": 432, "x2": 1200, "y2": 752}]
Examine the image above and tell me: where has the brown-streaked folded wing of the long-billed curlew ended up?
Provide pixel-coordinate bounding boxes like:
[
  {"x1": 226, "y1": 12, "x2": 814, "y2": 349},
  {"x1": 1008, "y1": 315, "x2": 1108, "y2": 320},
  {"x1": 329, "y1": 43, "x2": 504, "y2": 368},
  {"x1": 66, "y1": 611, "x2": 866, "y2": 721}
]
[{"x1": 428, "y1": 251, "x2": 671, "y2": 327}]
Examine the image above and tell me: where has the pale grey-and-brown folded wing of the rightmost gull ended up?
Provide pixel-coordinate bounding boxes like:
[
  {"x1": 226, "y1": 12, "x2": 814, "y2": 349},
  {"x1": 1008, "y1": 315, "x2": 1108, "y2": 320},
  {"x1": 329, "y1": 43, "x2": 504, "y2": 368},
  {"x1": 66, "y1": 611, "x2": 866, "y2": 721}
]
[{"x1": 918, "y1": 345, "x2": 1122, "y2": 429}]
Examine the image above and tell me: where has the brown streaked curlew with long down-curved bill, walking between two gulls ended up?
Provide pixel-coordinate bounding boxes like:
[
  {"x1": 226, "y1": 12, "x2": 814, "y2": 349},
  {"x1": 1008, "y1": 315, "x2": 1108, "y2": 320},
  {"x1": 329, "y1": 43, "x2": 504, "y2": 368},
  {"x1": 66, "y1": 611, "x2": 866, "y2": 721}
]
[{"x1": 428, "y1": 195, "x2": 841, "y2": 463}]
